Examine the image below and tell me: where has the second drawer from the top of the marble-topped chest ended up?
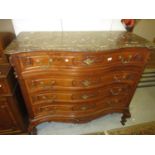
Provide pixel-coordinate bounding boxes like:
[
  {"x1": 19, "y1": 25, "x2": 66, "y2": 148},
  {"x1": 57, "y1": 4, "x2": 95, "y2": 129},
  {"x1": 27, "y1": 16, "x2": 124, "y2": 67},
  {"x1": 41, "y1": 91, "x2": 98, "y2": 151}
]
[{"x1": 24, "y1": 68, "x2": 139, "y2": 92}]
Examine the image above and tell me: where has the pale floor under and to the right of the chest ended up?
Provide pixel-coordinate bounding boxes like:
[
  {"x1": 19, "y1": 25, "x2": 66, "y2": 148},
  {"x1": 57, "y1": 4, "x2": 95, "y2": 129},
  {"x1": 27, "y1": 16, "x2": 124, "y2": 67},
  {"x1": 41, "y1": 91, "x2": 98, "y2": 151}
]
[{"x1": 37, "y1": 87, "x2": 155, "y2": 135}]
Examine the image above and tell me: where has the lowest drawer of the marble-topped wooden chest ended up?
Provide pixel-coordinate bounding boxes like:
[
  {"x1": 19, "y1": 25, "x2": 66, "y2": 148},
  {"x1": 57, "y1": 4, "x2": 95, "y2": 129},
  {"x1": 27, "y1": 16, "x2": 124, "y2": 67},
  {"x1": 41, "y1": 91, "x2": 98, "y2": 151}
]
[{"x1": 33, "y1": 96, "x2": 128, "y2": 116}]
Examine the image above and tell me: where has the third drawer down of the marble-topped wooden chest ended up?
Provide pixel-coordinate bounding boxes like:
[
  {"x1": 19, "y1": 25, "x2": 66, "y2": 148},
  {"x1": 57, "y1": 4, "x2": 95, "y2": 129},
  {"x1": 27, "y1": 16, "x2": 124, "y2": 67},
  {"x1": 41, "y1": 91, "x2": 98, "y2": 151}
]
[{"x1": 29, "y1": 83, "x2": 132, "y2": 105}]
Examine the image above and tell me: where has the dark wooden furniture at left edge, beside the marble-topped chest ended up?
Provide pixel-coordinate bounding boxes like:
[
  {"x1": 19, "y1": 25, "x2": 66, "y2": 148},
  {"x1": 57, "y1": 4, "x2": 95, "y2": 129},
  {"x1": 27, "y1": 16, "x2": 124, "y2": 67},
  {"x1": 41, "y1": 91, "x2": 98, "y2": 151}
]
[{"x1": 0, "y1": 33, "x2": 27, "y2": 134}]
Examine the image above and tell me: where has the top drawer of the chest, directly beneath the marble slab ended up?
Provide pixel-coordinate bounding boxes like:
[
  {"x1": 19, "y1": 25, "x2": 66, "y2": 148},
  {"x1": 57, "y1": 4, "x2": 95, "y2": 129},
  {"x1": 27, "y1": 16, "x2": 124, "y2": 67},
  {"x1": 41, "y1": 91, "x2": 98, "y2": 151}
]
[{"x1": 10, "y1": 48, "x2": 147, "y2": 71}]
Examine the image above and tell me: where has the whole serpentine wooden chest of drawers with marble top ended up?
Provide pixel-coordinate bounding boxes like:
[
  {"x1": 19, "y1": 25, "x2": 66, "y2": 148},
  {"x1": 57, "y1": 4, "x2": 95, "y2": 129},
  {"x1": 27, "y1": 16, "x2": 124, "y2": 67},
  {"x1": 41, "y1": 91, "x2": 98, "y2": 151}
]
[{"x1": 5, "y1": 32, "x2": 154, "y2": 132}]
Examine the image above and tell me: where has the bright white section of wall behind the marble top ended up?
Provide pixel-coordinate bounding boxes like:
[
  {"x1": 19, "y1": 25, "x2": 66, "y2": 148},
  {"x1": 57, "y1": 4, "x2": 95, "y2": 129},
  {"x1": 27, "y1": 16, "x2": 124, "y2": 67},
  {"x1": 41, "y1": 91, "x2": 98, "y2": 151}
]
[{"x1": 13, "y1": 19, "x2": 124, "y2": 35}]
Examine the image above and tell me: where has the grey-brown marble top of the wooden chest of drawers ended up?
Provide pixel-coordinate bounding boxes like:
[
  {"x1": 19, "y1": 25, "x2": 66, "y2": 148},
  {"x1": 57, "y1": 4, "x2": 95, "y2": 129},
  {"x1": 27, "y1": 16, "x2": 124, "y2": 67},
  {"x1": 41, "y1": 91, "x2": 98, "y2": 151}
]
[{"x1": 4, "y1": 31, "x2": 155, "y2": 54}]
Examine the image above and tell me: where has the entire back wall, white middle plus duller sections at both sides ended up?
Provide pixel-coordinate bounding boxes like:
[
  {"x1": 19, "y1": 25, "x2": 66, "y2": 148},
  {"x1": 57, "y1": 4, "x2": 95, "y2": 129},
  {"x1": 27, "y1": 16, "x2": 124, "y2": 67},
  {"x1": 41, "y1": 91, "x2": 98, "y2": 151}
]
[{"x1": 0, "y1": 19, "x2": 155, "y2": 41}]
